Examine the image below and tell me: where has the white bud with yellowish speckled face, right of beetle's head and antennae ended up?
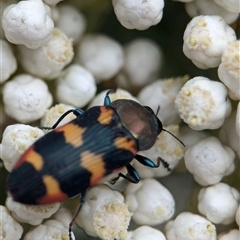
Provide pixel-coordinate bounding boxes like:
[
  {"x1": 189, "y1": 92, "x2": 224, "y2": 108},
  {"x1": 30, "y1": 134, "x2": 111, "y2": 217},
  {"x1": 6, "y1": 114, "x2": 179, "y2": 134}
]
[{"x1": 175, "y1": 77, "x2": 231, "y2": 130}]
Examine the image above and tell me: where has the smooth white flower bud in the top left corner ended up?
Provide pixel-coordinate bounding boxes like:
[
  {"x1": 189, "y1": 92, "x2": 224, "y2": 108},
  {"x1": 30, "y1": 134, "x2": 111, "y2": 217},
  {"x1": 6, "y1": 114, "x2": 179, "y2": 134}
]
[{"x1": 2, "y1": 0, "x2": 54, "y2": 49}]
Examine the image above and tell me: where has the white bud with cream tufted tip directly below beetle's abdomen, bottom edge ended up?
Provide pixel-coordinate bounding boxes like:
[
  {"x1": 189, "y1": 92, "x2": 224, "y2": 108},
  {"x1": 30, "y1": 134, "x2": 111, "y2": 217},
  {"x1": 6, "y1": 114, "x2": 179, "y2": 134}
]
[{"x1": 76, "y1": 184, "x2": 131, "y2": 240}]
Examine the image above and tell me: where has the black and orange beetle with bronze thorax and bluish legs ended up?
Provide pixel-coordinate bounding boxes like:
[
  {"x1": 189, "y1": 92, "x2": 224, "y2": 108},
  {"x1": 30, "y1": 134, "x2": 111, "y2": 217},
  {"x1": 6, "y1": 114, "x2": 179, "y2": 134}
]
[{"x1": 7, "y1": 91, "x2": 178, "y2": 238}]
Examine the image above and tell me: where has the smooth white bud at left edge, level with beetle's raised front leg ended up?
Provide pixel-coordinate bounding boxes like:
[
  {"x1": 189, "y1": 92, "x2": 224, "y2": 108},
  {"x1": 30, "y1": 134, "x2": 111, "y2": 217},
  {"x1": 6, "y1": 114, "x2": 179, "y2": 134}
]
[{"x1": 3, "y1": 74, "x2": 53, "y2": 123}]
